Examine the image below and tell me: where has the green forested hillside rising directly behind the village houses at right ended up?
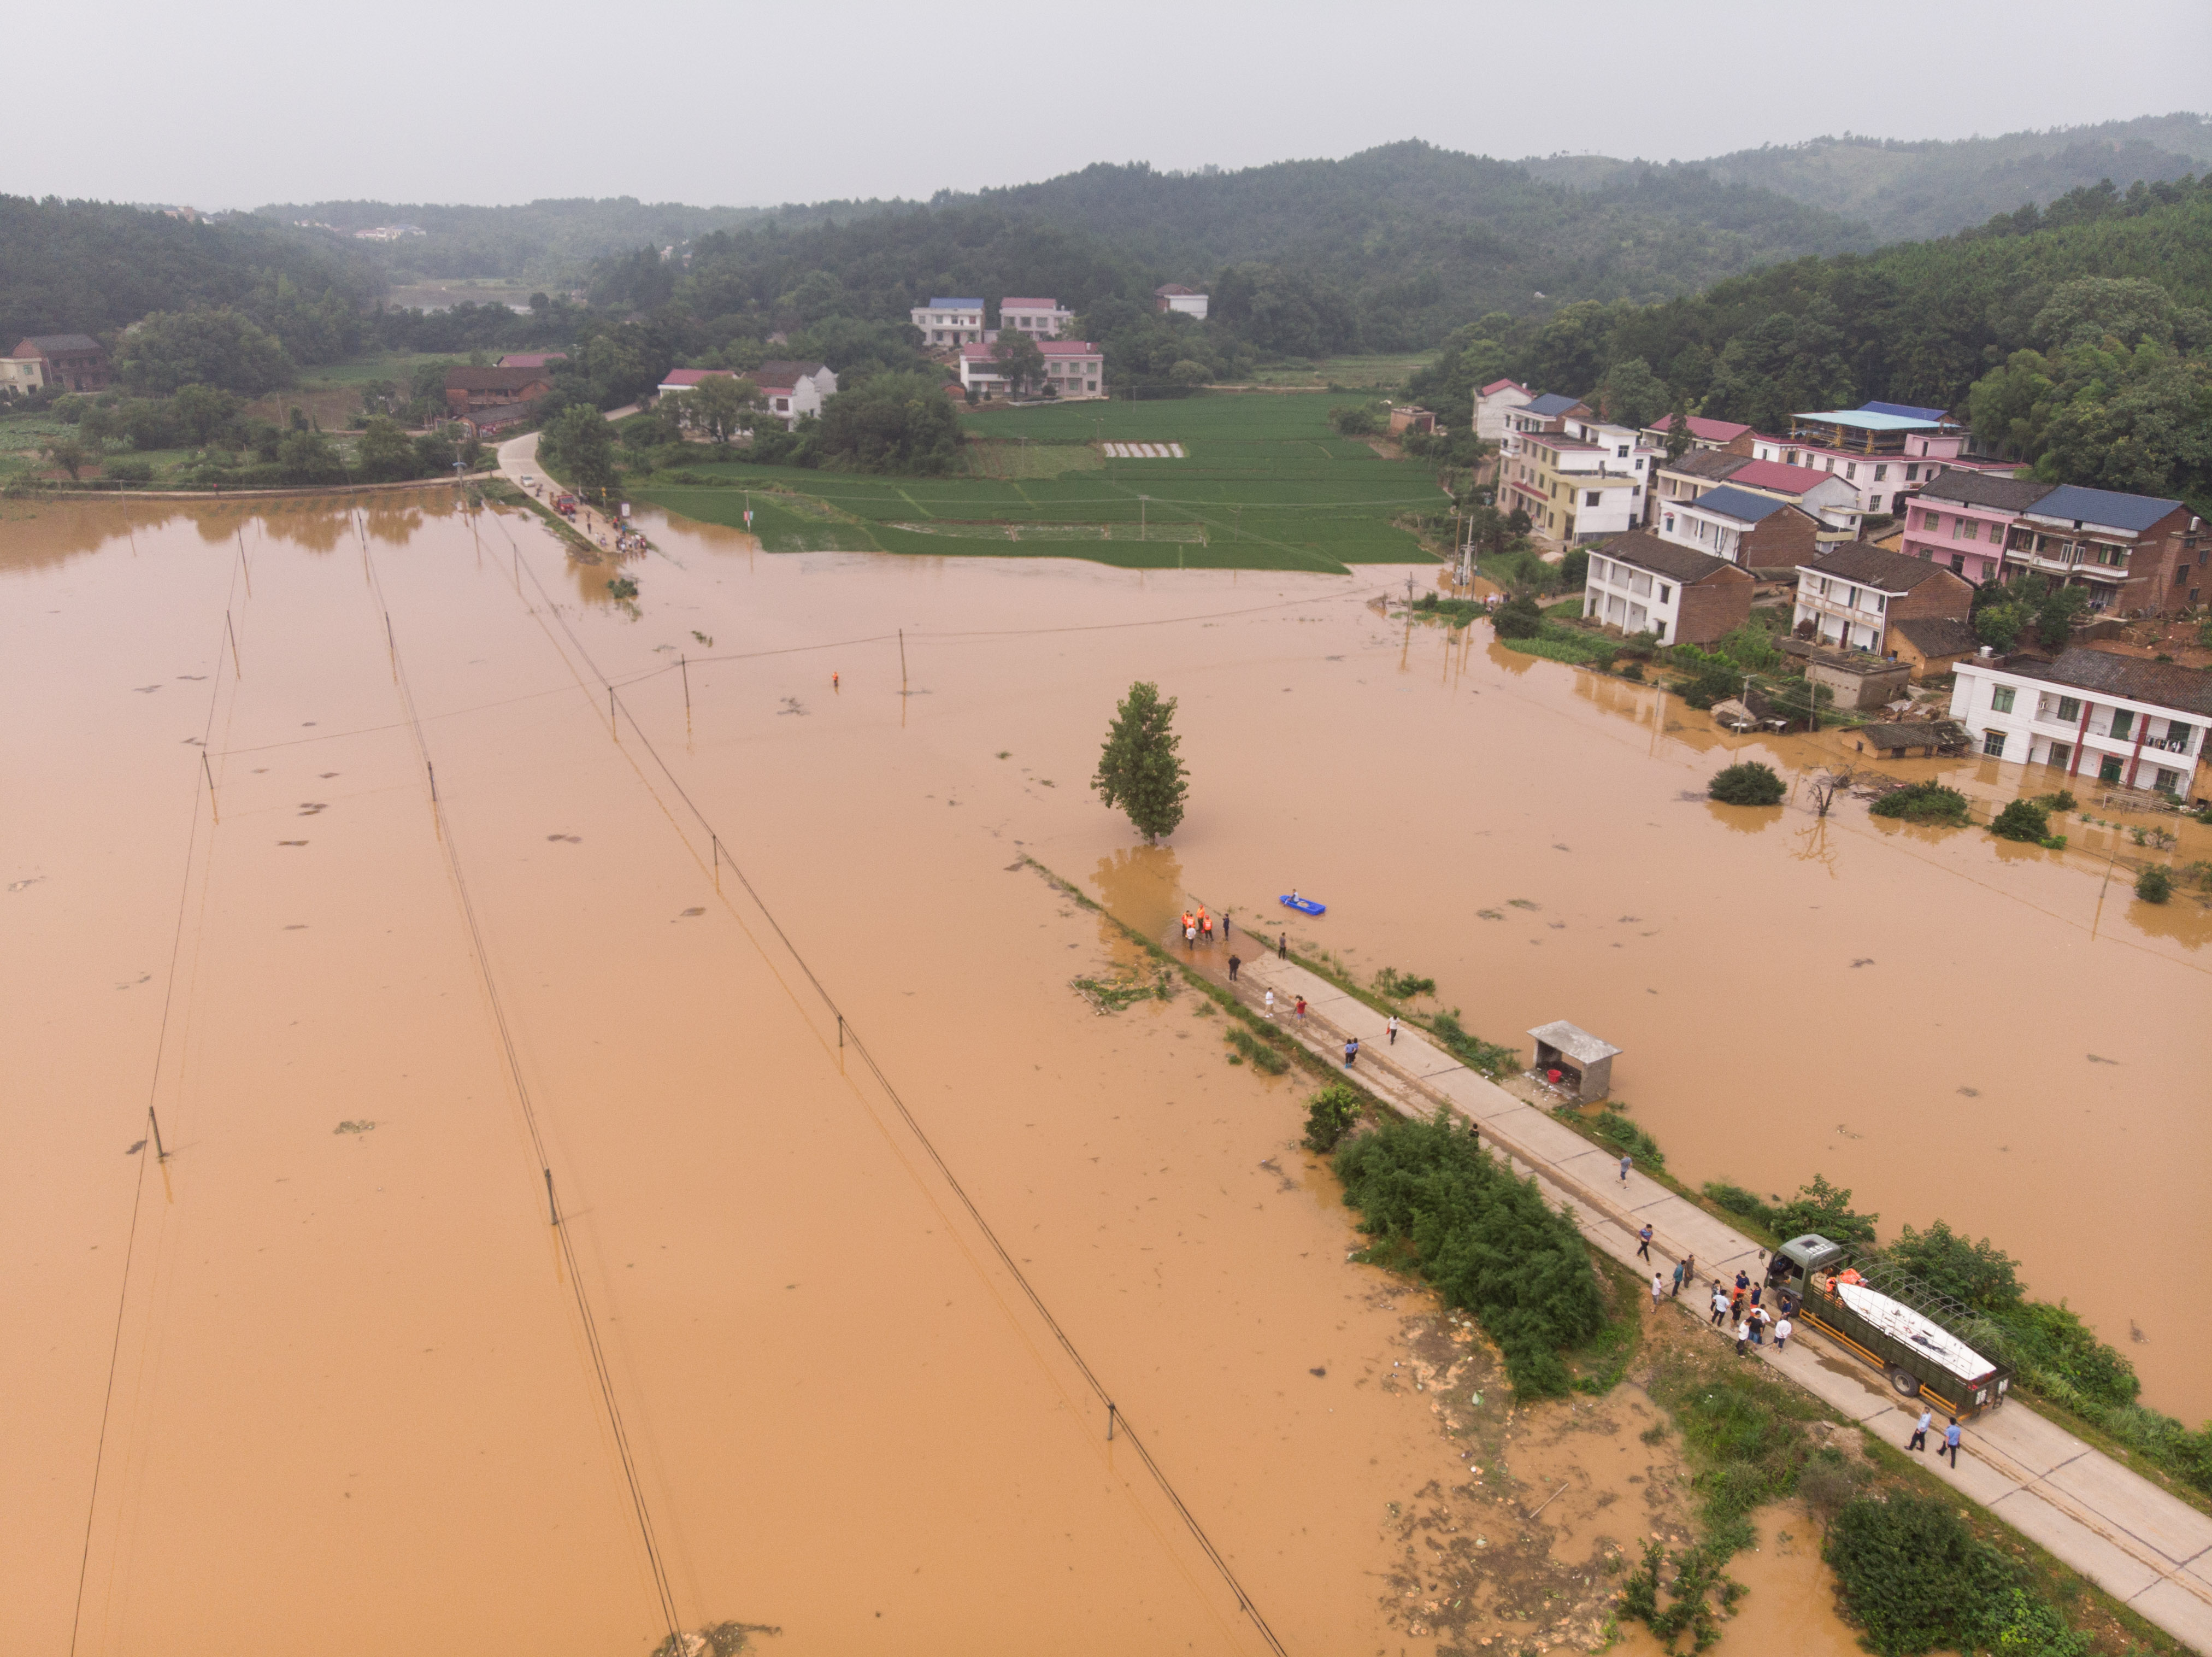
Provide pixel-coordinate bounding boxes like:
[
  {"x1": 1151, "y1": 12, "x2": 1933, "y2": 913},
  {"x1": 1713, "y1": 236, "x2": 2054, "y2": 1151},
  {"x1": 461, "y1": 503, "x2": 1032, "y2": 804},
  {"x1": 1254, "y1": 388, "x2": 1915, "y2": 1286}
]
[{"x1": 1411, "y1": 177, "x2": 2212, "y2": 498}]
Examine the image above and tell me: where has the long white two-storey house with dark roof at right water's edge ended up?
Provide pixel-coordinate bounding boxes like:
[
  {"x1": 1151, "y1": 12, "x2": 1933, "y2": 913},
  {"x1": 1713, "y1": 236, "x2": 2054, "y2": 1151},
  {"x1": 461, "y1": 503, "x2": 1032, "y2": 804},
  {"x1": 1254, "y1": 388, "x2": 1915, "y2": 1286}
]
[{"x1": 1951, "y1": 648, "x2": 2212, "y2": 798}]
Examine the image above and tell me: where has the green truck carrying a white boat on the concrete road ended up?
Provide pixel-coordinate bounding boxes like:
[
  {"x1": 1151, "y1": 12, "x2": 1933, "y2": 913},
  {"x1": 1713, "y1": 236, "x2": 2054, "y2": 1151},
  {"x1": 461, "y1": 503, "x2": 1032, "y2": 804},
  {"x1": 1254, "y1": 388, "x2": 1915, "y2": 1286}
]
[{"x1": 1767, "y1": 1232, "x2": 2013, "y2": 1420}]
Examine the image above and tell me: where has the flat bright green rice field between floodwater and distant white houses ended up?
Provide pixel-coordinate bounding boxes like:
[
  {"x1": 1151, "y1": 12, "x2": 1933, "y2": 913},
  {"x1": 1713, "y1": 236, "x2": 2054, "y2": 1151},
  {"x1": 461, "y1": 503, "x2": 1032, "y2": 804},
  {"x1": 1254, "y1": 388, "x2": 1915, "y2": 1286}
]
[{"x1": 631, "y1": 394, "x2": 1449, "y2": 573}]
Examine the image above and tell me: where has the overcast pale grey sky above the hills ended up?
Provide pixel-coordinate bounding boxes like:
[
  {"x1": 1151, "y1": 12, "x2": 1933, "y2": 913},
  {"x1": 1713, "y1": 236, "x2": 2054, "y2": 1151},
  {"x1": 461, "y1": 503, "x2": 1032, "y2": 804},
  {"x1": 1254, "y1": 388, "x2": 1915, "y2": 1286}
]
[{"x1": 30, "y1": 0, "x2": 2212, "y2": 205}]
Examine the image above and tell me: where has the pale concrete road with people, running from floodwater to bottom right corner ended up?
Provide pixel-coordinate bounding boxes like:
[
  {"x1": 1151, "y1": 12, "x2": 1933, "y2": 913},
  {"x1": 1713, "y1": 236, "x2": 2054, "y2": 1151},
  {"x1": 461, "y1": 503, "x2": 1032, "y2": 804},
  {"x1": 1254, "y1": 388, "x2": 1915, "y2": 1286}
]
[{"x1": 1221, "y1": 933, "x2": 2212, "y2": 1653}]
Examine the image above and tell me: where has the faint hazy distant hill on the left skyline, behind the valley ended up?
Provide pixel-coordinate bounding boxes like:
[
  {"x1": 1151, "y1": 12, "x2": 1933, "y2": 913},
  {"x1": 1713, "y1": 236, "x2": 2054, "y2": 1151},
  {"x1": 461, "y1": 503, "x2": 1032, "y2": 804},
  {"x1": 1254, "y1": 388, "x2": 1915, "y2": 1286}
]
[{"x1": 257, "y1": 195, "x2": 896, "y2": 287}]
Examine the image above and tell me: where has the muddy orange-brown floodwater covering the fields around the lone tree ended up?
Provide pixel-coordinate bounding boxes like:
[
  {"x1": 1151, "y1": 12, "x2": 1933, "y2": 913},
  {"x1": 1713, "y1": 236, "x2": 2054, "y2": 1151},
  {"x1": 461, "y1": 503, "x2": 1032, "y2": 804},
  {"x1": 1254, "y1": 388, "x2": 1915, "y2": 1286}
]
[{"x1": 0, "y1": 493, "x2": 2212, "y2": 1657}]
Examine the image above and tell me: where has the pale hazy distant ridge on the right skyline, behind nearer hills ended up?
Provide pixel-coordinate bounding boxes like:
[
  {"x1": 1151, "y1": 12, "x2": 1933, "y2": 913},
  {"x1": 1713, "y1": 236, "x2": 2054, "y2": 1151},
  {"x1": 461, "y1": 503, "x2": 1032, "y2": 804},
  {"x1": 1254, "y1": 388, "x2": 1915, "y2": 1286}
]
[{"x1": 1524, "y1": 113, "x2": 2212, "y2": 241}]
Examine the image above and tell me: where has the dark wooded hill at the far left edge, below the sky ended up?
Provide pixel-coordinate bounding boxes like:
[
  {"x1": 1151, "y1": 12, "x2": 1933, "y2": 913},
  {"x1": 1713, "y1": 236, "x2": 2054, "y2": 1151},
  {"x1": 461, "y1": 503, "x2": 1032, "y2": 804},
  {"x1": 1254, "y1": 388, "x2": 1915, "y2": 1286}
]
[{"x1": 0, "y1": 195, "x2": 385, "y2": 352}]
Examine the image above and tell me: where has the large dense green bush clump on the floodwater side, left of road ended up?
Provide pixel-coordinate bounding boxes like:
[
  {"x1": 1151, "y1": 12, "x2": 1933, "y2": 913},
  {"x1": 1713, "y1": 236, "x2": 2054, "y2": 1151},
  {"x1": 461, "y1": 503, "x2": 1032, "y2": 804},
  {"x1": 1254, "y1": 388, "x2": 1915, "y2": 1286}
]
[{"x1": 1336, "y1": 1113, "x2": 1606, "y2": 1398}]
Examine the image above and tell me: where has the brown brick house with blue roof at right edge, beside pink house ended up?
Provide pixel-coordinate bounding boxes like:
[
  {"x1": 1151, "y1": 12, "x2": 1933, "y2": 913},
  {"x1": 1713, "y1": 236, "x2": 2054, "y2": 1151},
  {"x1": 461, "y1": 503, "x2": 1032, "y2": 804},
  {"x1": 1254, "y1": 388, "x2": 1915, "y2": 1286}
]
[{"x1": 1999, "y1": 485, "x2": 2212, "y2": 615}]
